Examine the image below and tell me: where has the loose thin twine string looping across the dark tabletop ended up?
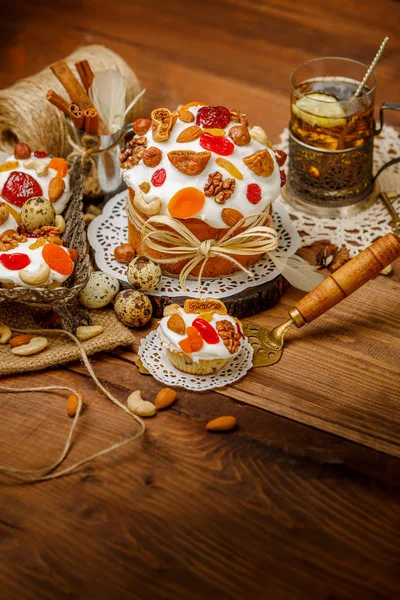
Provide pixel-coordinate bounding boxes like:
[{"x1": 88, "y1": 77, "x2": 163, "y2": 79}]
[{"x1": 0, "y1": 328, "x2": 146, "y2": 483}]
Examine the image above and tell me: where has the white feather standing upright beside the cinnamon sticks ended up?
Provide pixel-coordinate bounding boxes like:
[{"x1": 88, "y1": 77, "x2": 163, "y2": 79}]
[{"x1": 89, "y1": 69, "x2": 126, "y2": 133}]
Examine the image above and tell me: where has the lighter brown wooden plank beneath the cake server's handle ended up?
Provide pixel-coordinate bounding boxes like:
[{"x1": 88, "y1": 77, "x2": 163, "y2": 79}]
[{"x1": 123, "y1": 268, "x2": 400, "y2": 457}]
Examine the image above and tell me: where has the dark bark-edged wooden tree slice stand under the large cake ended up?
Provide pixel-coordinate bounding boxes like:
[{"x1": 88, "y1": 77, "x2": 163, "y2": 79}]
[{"x1": 121, "y1": 275, "x2": 289, "y2": 319}]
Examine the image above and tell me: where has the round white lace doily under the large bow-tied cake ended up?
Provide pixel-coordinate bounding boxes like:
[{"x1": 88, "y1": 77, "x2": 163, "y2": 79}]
[{"x1": 88, "y1": 191, "x2": 300, "y2": 298}]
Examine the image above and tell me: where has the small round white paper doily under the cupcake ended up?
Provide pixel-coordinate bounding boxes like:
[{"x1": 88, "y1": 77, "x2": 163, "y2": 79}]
[{"x1": 138, "y1": 331, "x2": 253, "y2": 391}]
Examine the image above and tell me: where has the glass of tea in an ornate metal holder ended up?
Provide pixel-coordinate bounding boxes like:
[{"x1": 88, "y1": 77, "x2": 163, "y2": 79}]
[{"x1": 284, "y1": 57, "x2": 400, "y2": 217}]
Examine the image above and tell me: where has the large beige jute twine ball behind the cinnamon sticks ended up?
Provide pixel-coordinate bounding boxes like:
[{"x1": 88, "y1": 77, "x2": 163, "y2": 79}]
[{"x1": 0, "y1": 45, "x2": 141, "y2": 156}]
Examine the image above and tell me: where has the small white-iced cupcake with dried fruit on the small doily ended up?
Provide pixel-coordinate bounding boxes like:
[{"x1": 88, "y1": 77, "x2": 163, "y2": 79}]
[{"x1": 158, "y1": 298, "x2": 246, "y2": 375}]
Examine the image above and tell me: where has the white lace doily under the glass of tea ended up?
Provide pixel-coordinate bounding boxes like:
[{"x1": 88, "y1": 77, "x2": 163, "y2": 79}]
[{"x1": 275, "y1": 125, "x2": 400, "y2": 256}]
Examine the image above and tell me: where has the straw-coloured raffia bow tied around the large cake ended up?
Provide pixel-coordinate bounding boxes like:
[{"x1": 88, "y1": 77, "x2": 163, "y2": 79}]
[{"x1": 126, "y1": 200, "x2": 323, "y2": 296}]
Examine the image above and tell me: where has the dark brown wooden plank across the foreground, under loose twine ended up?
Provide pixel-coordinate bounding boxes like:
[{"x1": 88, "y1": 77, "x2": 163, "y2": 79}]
[{"x1": 0, "y1": 358, "x2": 400, "y2": 600}]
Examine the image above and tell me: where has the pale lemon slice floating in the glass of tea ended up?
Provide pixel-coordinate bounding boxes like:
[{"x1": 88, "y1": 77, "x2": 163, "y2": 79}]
[{"x1": 292, "y1": 92, "x2": 346, "y2": 127}]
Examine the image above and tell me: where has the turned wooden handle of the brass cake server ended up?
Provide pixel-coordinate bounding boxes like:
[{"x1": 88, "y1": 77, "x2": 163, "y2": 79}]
[{"x1": 289, "y1": 233, "x2": 400, "y2": 327}]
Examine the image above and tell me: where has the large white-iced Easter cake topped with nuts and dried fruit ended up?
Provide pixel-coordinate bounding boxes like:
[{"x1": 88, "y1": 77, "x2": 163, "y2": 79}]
[{"x1": 120, "y1": 102, "x2": 286, "y2": 278}]
